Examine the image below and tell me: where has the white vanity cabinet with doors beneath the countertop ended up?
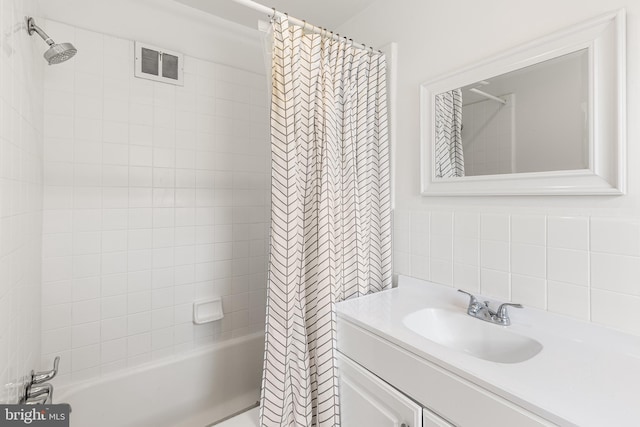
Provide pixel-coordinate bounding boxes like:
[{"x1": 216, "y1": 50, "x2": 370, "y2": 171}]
[{"x1": 338, "y1": 317, "x2": 556, "y2": 427}]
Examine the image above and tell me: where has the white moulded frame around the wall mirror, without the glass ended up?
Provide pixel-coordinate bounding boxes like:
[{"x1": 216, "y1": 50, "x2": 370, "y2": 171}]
[{"x1": 420, "y1": 10, "x2": 627, "y2": 196}]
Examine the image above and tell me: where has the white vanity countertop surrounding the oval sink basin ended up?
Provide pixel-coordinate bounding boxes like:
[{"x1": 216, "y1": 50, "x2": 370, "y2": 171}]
[{"x1": 337, "y1": 277, "x2": 640, "y2": 427}]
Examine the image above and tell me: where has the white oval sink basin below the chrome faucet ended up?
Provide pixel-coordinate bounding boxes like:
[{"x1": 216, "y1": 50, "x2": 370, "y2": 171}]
[{"x1": 402, "y1": 308, "x2": 542, "y2": 363}]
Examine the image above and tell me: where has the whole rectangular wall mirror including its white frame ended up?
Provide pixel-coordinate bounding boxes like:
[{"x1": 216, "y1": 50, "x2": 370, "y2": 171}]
[{"x1": 420, "y1": 11, "x2": 626, "y2": 196}]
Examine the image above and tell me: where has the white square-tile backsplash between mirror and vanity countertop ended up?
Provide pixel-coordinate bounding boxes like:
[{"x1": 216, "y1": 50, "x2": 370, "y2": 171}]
[{"x1": 394, "y1": 210, "x2": 640, "y2": 335}]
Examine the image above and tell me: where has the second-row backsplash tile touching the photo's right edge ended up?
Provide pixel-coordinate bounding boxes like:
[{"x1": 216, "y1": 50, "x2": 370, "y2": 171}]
[{"x1": 591, "y1": 252, "x2": 640, "y2": 296}]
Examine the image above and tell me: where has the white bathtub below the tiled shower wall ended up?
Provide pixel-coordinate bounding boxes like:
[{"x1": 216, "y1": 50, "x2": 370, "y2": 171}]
[{"x1": 54, "y1": 333, "x2": 264, "y2": 427}]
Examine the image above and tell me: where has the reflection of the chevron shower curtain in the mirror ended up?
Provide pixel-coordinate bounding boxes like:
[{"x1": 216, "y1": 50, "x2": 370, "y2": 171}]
[{"x1": 435, "y1": 89, "x2": 464, "y2": 178}]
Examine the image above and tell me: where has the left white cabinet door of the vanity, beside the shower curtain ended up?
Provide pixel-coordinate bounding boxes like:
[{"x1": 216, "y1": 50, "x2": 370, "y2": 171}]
[{"x1": 338, "y1": 353, "x2": 422, "y2": 427}]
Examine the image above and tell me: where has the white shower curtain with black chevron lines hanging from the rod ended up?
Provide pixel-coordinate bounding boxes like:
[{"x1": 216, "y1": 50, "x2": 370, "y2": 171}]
[{"x1": 260, "y1": 17, "x2": 391, "y2": 427}]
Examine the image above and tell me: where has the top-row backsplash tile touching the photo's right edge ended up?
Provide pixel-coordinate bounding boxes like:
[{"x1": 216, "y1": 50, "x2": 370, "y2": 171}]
[{"x1": 590, "y1": 218, "x2": 640, "y2": 256}]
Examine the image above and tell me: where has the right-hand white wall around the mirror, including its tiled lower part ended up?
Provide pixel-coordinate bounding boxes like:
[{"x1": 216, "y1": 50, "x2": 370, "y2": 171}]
[{"x1": 337, "y1": 0, "x2": 640, "y2": 335}]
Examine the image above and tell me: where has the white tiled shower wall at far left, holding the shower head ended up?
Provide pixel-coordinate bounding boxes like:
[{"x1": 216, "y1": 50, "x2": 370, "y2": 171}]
[{"x1": 0, "y1": 0, "x2": 46, "y2": 403}]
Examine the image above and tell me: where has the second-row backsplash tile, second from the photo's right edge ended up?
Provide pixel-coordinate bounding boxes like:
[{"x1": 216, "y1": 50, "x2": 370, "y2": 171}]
[{"x1": 547, "y1": 248, "x2": 589, "y2": 286}]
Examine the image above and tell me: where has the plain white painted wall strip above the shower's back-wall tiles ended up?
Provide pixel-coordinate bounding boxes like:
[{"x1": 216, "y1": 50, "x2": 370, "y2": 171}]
[{"x1": 37, "y1": 0, "x2": 265, "y2": 74}]
